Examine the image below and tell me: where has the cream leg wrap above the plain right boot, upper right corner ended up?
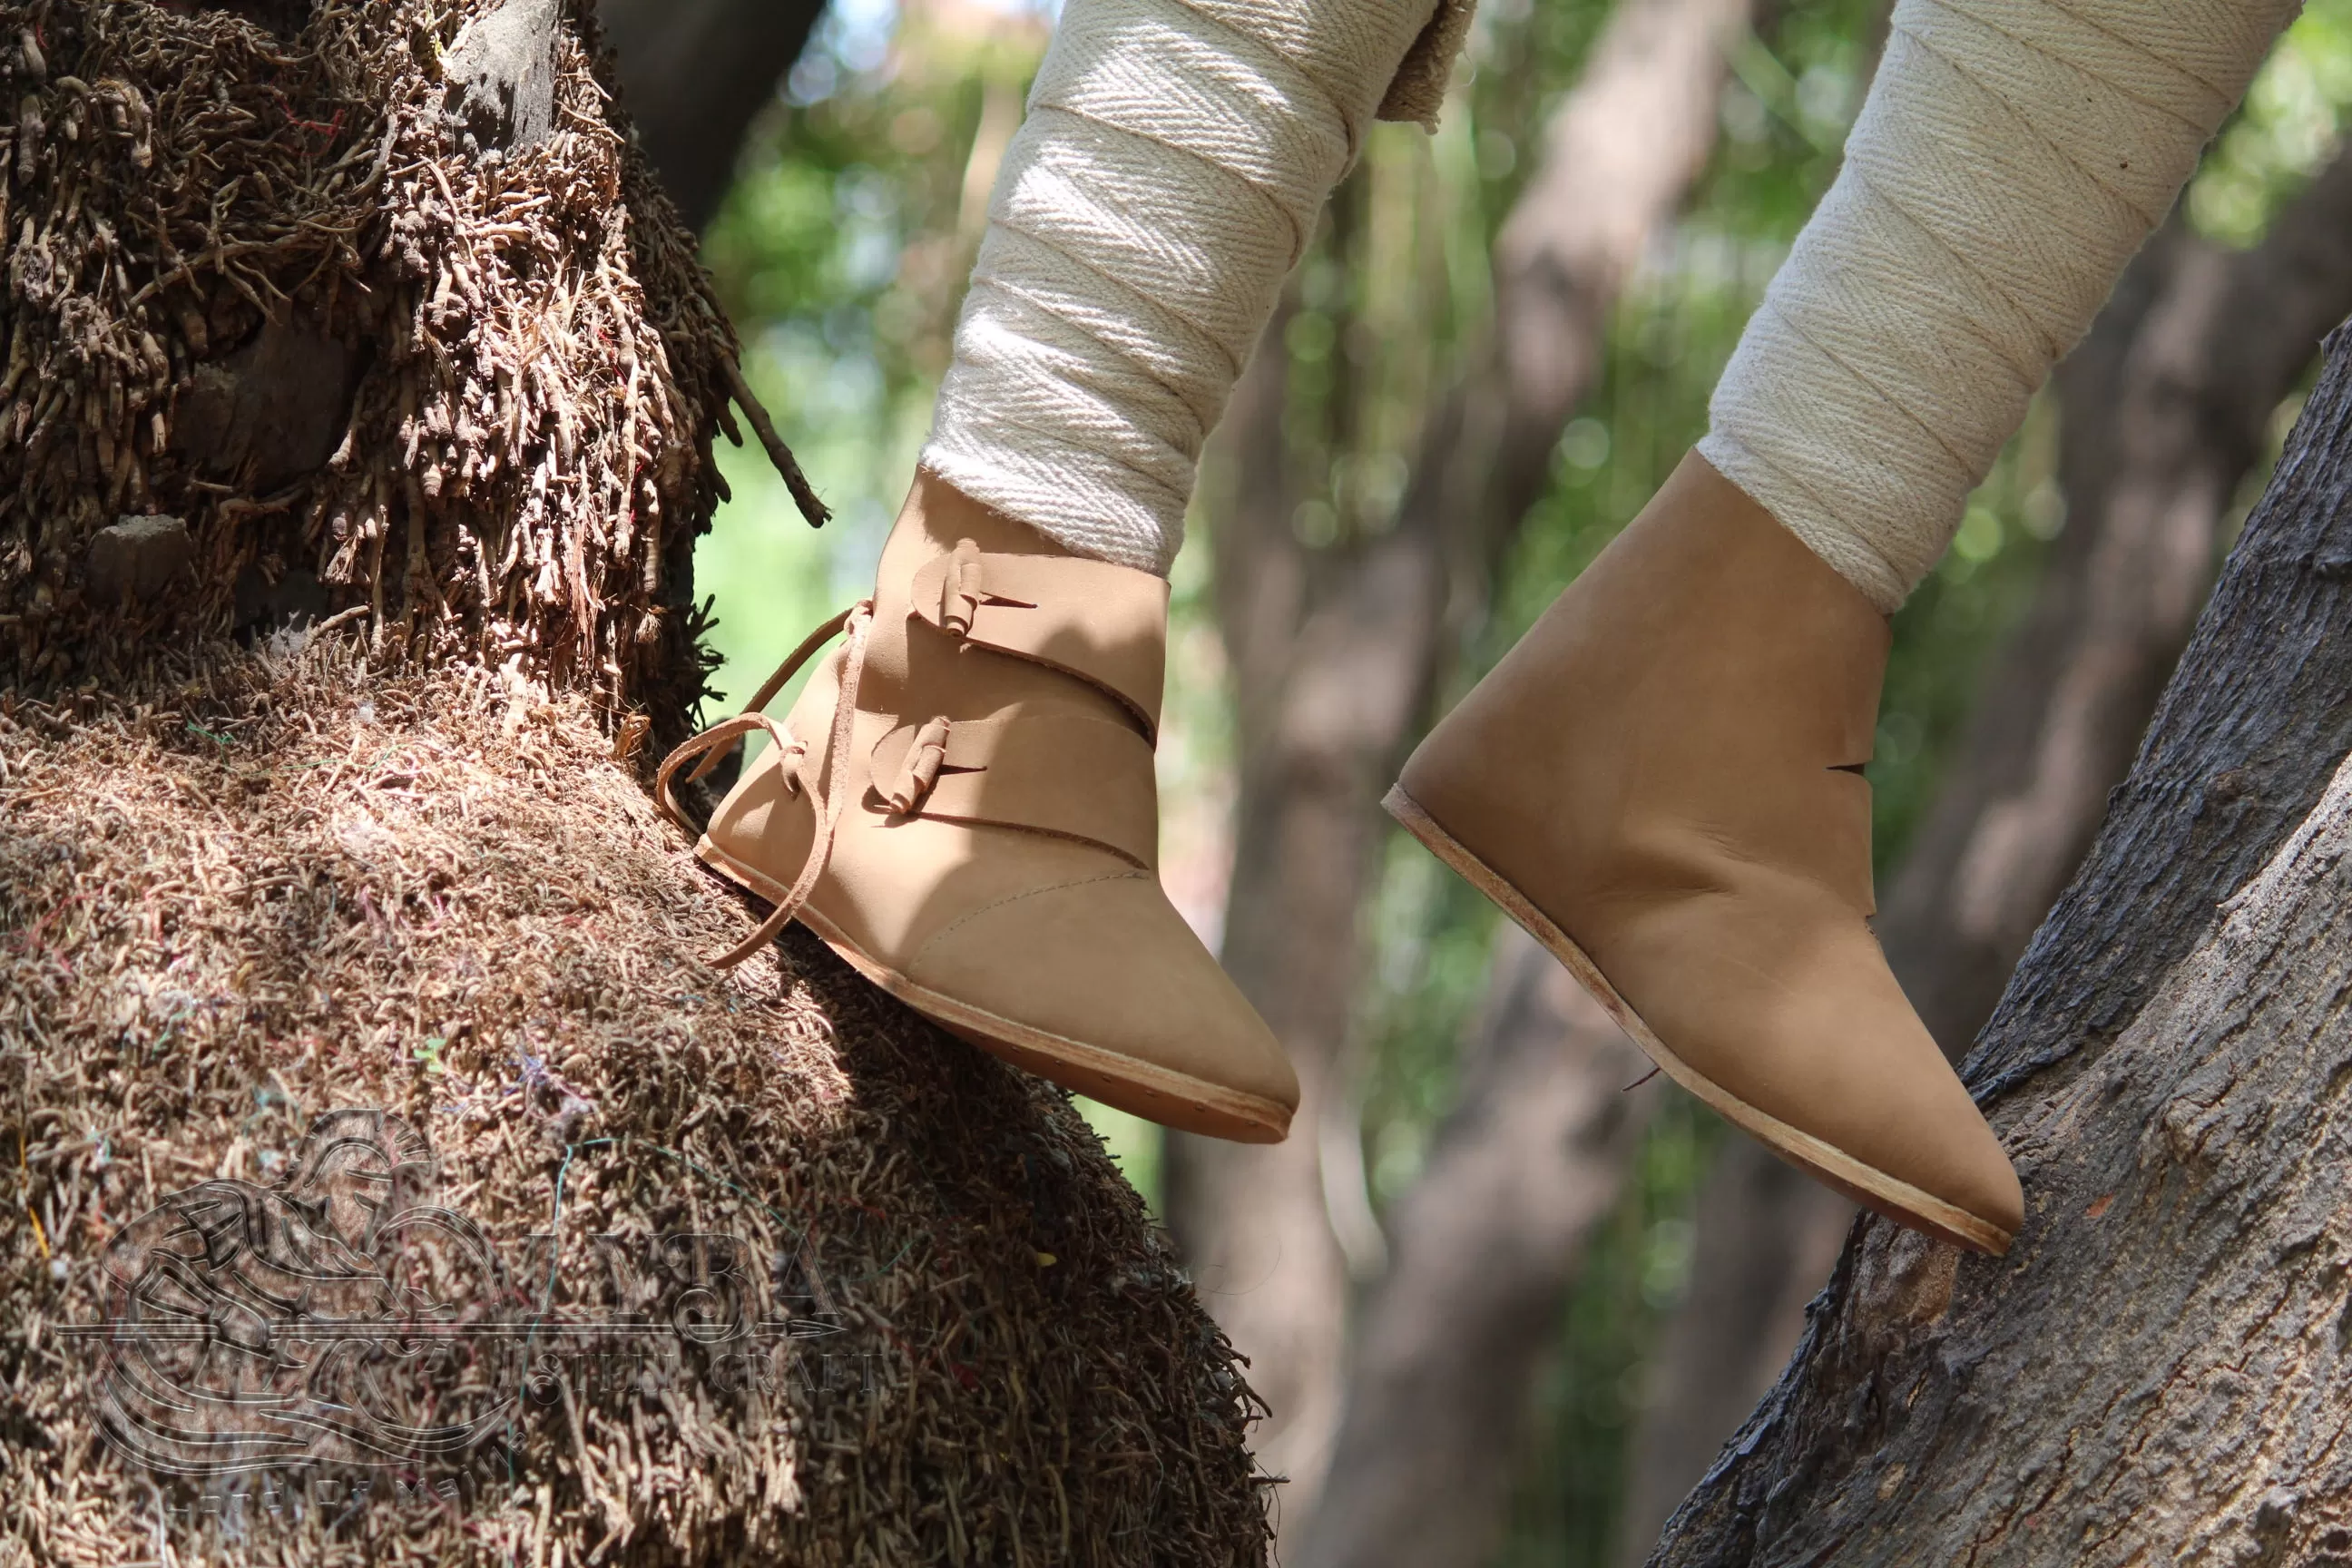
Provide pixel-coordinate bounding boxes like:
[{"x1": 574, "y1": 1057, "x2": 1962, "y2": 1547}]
[{"x1": 1698, "y1": 0, "x2": 2298, "y2": 612}]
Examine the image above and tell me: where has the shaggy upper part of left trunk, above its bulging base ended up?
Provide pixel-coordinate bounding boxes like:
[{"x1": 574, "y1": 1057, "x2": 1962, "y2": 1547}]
[{"x1": 0, "y1": 0, "x2": 734, "y2": 738}]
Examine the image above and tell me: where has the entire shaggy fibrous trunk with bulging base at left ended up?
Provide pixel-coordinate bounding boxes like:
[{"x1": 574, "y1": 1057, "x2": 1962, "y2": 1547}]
[{"x1": 0, "y1": 0, "x2": 1268, "y2": 1565}]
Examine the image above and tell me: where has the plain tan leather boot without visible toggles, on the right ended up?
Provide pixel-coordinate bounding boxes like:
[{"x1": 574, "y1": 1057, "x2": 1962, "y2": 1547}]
[{"x1": 1386, "y1": 454, "x2": 2023, "y2": 1253}]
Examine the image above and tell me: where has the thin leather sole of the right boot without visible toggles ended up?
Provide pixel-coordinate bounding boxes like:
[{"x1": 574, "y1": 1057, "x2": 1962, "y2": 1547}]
[{"x1": 1381, "y1": 783, "x2": 2015, "y2": 1258}]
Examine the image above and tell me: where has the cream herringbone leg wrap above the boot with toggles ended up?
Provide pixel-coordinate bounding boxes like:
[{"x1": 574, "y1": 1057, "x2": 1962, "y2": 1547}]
[{"x1": 922, "y1": 0, "x2": 1437, "y2": 573}]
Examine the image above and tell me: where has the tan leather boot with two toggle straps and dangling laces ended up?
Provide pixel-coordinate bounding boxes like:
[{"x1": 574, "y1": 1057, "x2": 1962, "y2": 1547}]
[{"x1": 659, "y1": 473, "x2": 1298, "y2": 1142}]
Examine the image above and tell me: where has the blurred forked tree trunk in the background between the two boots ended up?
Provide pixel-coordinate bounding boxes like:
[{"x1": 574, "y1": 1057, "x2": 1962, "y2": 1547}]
[{"x1": 1169, "y1": 0, "x2": 1748, "y2": 1533}]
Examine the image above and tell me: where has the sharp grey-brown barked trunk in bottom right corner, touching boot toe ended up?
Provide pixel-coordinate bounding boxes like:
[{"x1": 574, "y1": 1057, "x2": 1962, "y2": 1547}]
[{"x1": 1651, "y1": 312, "x2": 2352, "y2": 1563}]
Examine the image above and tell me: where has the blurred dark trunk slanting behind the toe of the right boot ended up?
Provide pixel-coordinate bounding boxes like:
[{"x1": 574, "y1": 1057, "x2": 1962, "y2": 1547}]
[{"x1": 1621, "y1": 143, "x2": 2352, "y2": 1561}]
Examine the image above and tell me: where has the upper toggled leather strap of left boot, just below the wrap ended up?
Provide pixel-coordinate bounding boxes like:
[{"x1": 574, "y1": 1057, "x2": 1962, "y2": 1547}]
[{"x1": 910, "y1": 538, "x2": 1169, "y2": 740}]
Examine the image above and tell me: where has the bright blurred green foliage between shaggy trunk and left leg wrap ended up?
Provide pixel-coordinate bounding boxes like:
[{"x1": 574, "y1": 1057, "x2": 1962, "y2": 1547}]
[{"x1": 696, "y1": 5, "x2": 1046, "y2": 701}]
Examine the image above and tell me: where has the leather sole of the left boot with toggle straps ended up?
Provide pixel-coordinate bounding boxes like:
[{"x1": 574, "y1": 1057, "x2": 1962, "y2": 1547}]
[{"x1": 694, "y1": 835, "x2": 1291, "y2": 1142}]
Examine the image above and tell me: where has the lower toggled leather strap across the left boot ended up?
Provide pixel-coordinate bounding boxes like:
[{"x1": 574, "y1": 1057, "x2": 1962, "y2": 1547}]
[{"x1": 866, "y1": 703, "x2": 1160, "y2": 870}]
